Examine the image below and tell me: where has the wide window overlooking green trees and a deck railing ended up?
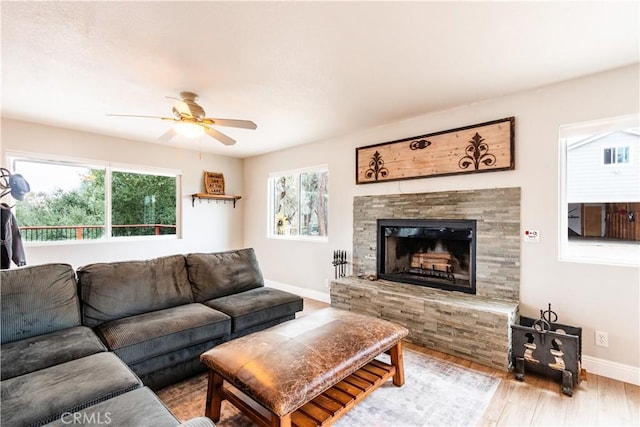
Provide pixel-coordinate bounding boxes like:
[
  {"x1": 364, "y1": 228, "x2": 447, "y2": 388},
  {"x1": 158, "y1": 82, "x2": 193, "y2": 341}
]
[{"x1": 8, "y1": 155, "x2": 180, "y2": 242}]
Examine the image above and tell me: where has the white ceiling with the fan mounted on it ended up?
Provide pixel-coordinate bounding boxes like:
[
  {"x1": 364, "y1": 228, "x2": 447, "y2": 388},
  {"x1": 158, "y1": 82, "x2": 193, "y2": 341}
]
[{"x1": 1, "y1": 1, "x2": 640, "y2": 157}]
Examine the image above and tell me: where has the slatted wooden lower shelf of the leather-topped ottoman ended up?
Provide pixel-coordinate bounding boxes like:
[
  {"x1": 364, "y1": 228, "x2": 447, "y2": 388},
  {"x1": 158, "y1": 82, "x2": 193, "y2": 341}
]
[{"x1": 222, "y1": 359, "x2": 396, "y2": 427}]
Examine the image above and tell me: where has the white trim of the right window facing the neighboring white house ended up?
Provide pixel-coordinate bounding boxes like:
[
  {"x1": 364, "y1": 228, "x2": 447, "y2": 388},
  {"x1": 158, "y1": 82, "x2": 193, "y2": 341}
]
[{"x1": 558, "y1": 113, "x2": 640, "y2": 267}]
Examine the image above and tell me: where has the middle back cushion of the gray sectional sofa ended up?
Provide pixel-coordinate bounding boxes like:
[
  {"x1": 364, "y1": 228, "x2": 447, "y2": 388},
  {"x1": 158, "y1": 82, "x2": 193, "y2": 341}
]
[{"x1": 77, "y1": 255, "x2": 193, "y2": 328}]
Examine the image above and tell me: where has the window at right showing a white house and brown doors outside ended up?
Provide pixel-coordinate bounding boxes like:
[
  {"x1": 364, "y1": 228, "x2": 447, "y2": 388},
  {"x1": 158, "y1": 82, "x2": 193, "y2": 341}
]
[{"x1": 559, "y1": 115, "x2": 640, "y2": 265}]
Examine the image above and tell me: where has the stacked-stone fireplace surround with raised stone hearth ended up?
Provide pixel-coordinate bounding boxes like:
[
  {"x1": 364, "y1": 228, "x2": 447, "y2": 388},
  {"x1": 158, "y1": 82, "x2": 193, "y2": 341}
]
[{"x1": 330, "y1": 188, "x2": 520, "y2": 369}]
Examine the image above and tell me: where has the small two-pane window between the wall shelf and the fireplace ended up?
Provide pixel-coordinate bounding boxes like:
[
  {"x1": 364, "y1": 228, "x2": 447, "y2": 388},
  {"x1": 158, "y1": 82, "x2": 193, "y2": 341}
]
[{"x1": 268, "y1": 166, "x2": 329, "y2": 240}]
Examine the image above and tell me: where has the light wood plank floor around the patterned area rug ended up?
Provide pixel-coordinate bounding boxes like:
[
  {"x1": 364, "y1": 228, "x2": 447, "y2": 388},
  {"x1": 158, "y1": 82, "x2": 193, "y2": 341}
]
[{"x1": 300, "y1": 299, "x2": 640, "y2": 426}]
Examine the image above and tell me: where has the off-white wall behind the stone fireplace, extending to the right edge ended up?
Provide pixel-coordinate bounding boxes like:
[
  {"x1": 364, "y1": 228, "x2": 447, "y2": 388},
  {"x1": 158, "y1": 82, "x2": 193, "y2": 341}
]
[{"x1": 244, "y1": 65, "x2": 640, "y2": 381}]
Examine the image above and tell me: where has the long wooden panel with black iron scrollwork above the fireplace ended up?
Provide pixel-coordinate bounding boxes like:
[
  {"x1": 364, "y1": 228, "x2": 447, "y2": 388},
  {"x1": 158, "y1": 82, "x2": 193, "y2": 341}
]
[{"x1": 356, "y1": 117, "x2": 515, "y2": 184}]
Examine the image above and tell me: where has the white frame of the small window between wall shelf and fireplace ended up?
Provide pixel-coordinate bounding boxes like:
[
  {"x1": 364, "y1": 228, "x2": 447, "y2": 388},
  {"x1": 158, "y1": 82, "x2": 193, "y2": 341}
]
[{"x1": 267, "y1": 164, "x2": 329, "y2": 243}]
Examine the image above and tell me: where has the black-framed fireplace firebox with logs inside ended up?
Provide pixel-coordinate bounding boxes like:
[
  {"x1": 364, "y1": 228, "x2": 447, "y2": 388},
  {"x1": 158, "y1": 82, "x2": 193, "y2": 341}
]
[{"x1": 377, "y1": 219, "x2": 476, "y2": 294}]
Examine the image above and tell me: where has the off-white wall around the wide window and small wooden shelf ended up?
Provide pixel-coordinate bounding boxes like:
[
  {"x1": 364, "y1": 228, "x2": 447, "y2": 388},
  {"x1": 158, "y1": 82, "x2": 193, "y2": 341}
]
[{"x1": 2, "y1": 118, "x2": 244, "y2": 268}]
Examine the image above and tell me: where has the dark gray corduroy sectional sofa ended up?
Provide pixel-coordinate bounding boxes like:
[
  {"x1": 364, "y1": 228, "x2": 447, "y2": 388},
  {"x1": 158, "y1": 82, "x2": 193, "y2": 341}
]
[{"x1": 0, "y1": 249, "x2": 302, "y2": 426}]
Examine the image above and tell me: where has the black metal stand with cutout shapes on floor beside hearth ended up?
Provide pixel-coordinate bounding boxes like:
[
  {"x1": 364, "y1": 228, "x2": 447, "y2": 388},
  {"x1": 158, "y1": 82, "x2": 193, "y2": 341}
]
[{"x1": 511, "y1": 304, "x2": 585, "y2": 396}]
